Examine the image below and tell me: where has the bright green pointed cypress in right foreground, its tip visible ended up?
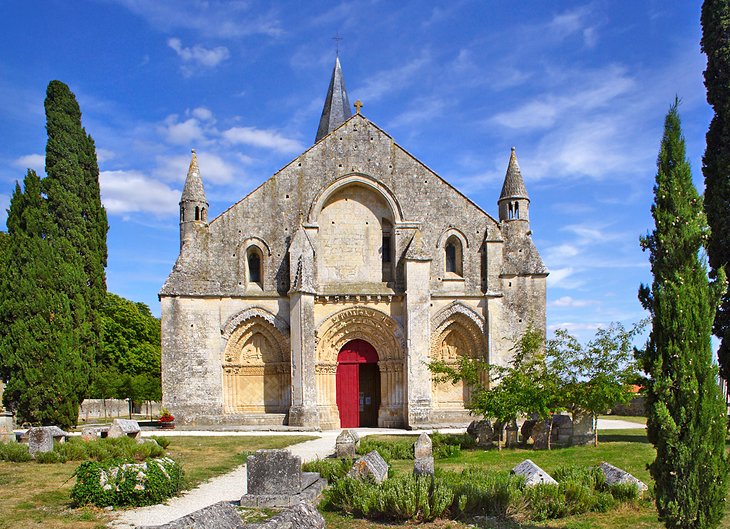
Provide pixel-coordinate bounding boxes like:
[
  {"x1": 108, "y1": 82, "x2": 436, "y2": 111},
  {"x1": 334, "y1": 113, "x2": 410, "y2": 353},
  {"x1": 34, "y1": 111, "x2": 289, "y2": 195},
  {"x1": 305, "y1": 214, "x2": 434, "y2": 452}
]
[{"x1": 639, "y1": 100, "x2": 727, "y2": 529}]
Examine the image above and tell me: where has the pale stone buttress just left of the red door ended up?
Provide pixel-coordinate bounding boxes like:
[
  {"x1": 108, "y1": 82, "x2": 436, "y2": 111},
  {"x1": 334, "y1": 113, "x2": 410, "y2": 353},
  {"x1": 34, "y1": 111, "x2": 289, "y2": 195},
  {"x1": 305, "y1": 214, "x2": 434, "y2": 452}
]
[{"x1": 289, "y1": 292, "x2": 319, "y2": 429}]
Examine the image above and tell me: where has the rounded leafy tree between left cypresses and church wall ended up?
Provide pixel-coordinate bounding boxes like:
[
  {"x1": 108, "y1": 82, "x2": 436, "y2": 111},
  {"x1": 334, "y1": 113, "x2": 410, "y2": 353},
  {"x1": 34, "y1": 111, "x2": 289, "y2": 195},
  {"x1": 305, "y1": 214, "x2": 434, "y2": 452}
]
[{"x1": 91, "y1": 292, "x2": 161, "y2": 402}]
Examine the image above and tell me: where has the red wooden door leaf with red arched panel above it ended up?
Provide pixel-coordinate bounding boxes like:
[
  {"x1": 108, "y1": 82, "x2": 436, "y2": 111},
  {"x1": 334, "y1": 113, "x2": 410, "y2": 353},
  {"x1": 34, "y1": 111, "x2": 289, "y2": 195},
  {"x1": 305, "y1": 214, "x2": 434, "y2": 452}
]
[{"x1": 335, "y1": 340, "x2": 378, "y2": 428}]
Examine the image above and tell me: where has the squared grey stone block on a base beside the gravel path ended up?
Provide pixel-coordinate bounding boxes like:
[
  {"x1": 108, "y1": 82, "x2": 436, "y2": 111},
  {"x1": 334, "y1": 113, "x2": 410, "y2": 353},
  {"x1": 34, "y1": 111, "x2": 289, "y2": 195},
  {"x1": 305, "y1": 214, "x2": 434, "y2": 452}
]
[{"x1": 246, "y1": 450, "x2": 302, "y2": 495}]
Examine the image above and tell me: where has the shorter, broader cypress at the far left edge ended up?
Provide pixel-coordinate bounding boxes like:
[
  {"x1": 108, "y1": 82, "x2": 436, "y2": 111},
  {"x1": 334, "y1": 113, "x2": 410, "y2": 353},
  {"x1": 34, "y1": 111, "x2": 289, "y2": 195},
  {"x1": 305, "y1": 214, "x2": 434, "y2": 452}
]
[{"x1": 0, "y1": 170, "x2": 90, "y2": 428}]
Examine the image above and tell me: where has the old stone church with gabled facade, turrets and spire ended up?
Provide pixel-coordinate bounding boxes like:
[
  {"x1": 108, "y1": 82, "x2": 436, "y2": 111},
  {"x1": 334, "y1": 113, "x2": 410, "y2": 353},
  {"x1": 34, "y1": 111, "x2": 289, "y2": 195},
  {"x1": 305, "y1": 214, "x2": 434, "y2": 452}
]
[{"x1": 159, "y1": 59, "x2": 548, "y2": 429}]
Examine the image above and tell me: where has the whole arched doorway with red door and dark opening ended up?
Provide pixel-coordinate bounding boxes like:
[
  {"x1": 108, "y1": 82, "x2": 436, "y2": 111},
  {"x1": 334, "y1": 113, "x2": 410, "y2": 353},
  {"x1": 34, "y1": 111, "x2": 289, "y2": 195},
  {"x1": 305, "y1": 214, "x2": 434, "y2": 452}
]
[{"x1": 336, "y1": 340, "x2": 380, "y2": 428}]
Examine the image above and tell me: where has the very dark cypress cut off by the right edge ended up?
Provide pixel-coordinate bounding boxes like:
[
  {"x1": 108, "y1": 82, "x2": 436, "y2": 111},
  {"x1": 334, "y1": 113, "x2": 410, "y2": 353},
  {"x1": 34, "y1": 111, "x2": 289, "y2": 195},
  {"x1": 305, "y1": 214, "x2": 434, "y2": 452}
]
[{"x1": 702, "y1": 0, "x2": 730, "y2": 380}]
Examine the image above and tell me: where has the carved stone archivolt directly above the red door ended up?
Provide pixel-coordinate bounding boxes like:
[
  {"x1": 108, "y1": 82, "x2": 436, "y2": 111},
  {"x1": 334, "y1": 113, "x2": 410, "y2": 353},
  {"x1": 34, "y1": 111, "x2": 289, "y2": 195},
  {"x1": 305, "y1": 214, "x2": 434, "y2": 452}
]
[{"x1": 315, "y1": 307, "x2": 405, "y2": 365}]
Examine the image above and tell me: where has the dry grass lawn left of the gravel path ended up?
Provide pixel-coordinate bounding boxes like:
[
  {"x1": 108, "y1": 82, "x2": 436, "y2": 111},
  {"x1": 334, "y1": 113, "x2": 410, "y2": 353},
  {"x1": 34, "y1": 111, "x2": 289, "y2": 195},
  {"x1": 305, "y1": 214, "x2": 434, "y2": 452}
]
[{"x1": 0, "y1": 435, "x2": 314, "y2": 529}]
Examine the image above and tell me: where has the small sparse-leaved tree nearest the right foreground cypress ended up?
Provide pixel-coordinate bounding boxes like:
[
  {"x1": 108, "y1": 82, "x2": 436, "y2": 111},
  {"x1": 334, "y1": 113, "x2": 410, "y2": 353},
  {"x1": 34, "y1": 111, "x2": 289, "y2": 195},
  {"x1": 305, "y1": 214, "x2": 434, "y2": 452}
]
[{"x1": 546, "y1": 323, "x2": 644, "y2": 446}]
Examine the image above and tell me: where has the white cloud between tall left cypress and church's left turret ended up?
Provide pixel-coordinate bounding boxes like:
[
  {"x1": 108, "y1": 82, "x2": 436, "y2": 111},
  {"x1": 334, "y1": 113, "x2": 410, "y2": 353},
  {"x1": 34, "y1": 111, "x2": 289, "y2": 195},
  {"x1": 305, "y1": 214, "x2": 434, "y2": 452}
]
[{"x1": 99, "y1": 171, "x2": 181, "y2": 216}]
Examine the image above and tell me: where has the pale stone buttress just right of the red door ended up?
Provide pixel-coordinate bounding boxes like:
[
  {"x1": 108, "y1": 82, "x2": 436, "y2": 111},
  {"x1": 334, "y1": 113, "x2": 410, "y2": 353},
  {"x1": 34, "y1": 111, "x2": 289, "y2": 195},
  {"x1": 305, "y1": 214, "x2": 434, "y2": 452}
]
[{"x1": 405, "y1": 250, "x2": 431, "y2": 428}]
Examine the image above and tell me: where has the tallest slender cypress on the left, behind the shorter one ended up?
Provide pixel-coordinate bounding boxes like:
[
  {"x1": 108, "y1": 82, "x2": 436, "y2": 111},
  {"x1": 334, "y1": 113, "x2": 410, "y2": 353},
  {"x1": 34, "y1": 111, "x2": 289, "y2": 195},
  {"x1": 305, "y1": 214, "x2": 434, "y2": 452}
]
[{"x1": 43, "y1": 81, "x2": 109, "y2": 385}]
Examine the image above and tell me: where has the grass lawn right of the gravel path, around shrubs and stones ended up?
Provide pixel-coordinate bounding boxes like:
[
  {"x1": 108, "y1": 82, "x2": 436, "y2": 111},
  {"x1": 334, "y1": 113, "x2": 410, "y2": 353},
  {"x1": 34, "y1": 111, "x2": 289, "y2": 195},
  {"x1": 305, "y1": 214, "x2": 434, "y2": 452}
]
[{"x1": 324, "y1": 428, "x2": 730, "y2": 529}]
